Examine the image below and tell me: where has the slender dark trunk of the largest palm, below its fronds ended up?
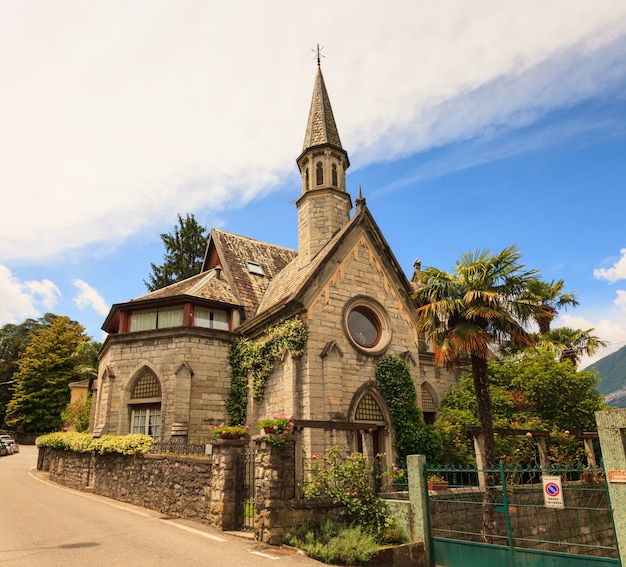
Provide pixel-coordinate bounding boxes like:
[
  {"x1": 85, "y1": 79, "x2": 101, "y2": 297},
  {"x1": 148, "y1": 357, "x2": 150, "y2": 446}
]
[{"x1": 471, "y1": 356, "x2": 496, "y2": 543}]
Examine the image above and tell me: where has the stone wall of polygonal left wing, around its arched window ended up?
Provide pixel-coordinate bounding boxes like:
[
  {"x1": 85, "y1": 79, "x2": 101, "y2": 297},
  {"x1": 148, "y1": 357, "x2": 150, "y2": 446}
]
[{"x1": 92, "y1": 327, "x2": 232, "y2": 440}]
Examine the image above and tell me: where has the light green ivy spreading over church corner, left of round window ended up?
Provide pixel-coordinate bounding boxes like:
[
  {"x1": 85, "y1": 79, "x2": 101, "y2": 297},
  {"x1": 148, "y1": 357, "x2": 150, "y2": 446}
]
[{"x1": 226, "y1": 317, "x2": 309, "y2": 424}]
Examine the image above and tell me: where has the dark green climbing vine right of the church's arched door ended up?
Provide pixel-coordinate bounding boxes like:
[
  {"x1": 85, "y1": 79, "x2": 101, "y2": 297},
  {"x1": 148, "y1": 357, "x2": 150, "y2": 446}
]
[{"x1": 376, "y1": 354, "x2": 443, "y2": 464}]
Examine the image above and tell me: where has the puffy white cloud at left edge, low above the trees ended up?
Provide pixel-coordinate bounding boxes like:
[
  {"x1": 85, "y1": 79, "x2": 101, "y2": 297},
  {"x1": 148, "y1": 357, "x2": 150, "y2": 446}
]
[{"x1": 0, "y1": 265, "x2": 61, "y2": 325}]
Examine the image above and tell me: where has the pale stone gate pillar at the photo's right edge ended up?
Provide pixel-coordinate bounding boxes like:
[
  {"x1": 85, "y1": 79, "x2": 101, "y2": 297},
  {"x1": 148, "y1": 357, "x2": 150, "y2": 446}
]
[{"x1": 596, "y1": 408, "x2": 626, "y2": 557}]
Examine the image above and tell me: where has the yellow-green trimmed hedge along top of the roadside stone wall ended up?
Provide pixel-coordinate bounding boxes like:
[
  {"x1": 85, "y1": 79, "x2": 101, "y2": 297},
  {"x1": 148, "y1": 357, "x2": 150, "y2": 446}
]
[{"x1": 35, "y1": 432, "x2": 152, "y2": 455}]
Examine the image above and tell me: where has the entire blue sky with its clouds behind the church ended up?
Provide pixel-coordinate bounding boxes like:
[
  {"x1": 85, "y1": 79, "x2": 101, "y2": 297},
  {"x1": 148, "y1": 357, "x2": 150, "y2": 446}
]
[{"x1": 0, "y1": 0, "x2": 626, "y2": 362}]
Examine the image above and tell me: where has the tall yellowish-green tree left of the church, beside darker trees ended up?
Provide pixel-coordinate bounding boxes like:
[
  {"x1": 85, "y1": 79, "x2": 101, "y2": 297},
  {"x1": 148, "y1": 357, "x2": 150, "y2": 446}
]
[{"x1": 5, "y1": 317, "x2": 89, "y2": 433}]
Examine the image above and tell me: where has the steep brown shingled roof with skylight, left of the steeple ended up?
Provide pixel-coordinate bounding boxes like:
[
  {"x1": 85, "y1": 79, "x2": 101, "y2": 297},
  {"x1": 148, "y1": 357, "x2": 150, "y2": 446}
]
[{"x1": 202, "y1": 228, "x2": 298, "y2": 318}]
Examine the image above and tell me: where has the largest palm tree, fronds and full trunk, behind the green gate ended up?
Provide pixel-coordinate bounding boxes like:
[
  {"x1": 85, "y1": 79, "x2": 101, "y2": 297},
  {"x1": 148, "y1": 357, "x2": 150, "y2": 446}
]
[{"x1": 412, "y1": 246, "x2": 541, "y2": 537}]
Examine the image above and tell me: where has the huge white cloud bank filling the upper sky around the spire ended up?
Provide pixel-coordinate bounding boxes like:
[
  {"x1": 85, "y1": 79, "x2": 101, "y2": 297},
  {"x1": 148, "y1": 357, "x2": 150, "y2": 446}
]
[{"x1": 0, "y1": 0, "x2": 626, "y2": 260}]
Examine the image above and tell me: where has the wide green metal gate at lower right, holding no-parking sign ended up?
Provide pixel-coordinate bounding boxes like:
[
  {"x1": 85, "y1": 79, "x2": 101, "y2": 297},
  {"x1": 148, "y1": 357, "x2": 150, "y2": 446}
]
[{"x1": 428, "y1": 463, "x2": 621, "y2": 567}]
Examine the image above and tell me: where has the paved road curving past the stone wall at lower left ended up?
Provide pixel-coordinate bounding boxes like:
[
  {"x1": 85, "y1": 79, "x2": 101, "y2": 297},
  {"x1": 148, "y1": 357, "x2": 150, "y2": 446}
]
[{"x1": 0, "y1": 446, "x2": 322, "y2": 567}]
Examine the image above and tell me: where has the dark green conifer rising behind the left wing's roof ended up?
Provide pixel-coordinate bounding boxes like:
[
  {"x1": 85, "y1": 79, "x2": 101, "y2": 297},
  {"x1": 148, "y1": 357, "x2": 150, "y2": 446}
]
[{"x1": 143, "y1": 213, "x2": 207, "y2": 291}]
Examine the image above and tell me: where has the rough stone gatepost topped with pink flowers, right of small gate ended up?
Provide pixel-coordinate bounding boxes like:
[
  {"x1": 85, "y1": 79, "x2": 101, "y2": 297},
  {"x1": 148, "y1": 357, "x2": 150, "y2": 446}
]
[{"x1": 254, "y1": 435, "x2": 299, "y2": 545}]
